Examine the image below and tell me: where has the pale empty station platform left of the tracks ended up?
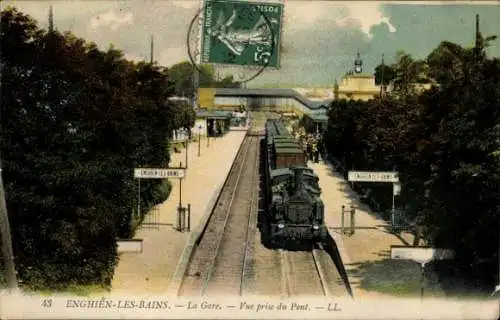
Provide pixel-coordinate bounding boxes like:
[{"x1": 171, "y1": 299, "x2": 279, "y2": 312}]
[{"x1": 111, "y1": 131, "x2": 246, "y2": 296}]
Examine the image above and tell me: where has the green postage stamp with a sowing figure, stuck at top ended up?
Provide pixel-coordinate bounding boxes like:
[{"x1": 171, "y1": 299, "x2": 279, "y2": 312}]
[{"x1": 201, "y1": 0, "x2": 284, "y2": 68}]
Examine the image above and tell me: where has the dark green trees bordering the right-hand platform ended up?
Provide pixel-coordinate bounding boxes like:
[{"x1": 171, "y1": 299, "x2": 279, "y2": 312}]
[{"x1": 325, "y1": 35, "x2": 500, "y2": 288}]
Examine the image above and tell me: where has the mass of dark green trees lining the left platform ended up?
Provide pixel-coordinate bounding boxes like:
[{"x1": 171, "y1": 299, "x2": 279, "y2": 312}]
[{"x1": 0, "y1": 8, "x2": 184, "y2": 289}]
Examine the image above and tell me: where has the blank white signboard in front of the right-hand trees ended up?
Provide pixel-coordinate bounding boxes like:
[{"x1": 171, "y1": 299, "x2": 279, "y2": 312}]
[{"x1": 391, "y1": 246, "x2": 455, "y2": 264}]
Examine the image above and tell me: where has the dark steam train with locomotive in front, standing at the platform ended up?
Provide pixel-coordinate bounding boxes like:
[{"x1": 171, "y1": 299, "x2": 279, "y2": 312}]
[{"x1": 260, "y1": 120, "x2": 327, "y2": 245}]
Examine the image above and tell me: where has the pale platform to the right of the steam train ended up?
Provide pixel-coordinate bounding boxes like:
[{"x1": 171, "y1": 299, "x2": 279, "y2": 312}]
[{"x1": 308, "y1": 161, "x2": 444, "y2": 300}]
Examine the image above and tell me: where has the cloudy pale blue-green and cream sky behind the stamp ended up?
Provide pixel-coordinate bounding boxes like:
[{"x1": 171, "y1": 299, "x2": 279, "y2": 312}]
[{"x1": 3, "y1": 0, "x2": 500, "y2": 87}]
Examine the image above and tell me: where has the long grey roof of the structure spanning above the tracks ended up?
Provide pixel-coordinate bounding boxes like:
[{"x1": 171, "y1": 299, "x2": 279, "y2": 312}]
[{"x1": 215, "y1": 88, "x2": 332, "y2": 110}]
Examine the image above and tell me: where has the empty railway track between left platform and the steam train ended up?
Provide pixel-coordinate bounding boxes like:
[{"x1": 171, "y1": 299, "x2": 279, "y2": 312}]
[{"x1": 179, "y1": 136, "x2": 259, "y2": 296}]
